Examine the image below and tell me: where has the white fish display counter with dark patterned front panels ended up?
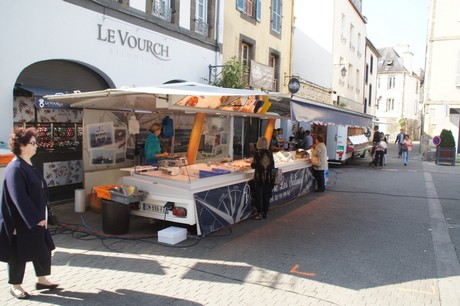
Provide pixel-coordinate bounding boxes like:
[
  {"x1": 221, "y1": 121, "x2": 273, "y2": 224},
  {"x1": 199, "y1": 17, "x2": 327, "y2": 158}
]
[{"x1": 122, "y1": 152, "x2": 315, "y2": 235}]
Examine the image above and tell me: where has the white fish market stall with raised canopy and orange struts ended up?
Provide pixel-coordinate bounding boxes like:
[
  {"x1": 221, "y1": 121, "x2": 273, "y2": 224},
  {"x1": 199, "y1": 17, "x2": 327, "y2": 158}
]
[{"x1": 45, "y1": 82, "x2": 315, "y2": 235}]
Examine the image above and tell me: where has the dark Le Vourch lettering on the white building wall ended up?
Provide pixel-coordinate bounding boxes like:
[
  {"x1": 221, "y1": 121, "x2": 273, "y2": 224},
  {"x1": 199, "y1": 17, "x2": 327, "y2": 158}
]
[{"x1": 97, "y1": 24, "x2": 171, "y2": 61}]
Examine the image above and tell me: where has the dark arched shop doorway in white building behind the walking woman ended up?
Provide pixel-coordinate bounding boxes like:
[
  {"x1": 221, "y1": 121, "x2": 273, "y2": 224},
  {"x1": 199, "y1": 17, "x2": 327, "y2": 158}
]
[{"x1": 13, "y1": 60, "x2": 114, "y2": 202}]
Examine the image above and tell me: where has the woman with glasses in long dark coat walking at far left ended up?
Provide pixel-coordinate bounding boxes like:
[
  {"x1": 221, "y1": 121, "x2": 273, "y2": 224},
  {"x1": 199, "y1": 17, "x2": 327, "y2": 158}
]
[{"x1": 0, "y1": 128, "x2": 58, "y2": 299}]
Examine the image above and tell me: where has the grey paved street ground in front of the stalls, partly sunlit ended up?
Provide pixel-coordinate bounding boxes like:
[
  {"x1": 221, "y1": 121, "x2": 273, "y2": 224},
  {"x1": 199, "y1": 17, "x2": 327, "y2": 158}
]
[{"x1": 0, "y1": 146, "x2": 460, "y2": 306}]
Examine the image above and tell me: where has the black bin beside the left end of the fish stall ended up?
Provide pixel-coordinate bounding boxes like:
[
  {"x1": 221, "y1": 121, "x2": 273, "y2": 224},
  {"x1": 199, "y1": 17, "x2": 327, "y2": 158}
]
[{"x1": 101, "y1": 199, "x2": 131, "y2": 235}]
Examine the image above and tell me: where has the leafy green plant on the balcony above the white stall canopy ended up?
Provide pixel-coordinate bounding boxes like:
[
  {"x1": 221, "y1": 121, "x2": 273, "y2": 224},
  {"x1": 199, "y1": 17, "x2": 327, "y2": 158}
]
[{"x1": 214, "y1": 56, "x2": 249, "y2": 89}]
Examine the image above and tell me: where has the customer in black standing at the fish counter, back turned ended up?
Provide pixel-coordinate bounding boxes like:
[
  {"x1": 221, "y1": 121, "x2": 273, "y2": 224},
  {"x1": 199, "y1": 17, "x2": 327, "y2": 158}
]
[{"x1": 251, "y1": 137, "x2": 275, "y2": 220}]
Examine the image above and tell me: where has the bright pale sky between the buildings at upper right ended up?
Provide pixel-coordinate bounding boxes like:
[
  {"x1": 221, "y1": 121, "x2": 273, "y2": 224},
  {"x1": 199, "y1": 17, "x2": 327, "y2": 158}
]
[{"x1": 362, "y1": 0, "x2": 430, "y2": 72}]
